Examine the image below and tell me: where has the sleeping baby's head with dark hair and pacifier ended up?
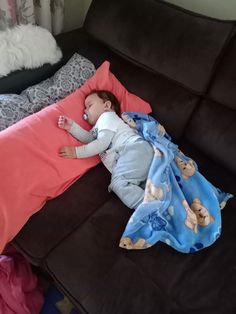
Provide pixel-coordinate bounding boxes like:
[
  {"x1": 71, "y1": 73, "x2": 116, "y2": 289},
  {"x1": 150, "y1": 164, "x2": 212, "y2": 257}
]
[{"x1": 85, "y1": 90, "x2": 120, "y2": 125}]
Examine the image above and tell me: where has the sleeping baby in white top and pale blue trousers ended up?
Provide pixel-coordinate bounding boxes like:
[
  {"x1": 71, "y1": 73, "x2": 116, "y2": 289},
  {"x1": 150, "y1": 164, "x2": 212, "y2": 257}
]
[{"x1": 58, "y1": 90, "x2": 154, "y2": 209}]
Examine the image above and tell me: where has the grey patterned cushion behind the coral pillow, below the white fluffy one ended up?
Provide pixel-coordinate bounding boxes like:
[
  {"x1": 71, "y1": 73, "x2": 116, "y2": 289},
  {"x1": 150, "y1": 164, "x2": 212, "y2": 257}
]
[{"x1": 0, "y1": 53, "x2": 95, "y2": 131}]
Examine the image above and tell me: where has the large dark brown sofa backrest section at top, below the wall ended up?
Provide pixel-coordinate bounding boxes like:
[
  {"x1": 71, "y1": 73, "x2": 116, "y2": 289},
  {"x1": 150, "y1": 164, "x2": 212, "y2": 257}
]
[{"x1": 85, "y1": 0, "x2": 233, "y2": 93}]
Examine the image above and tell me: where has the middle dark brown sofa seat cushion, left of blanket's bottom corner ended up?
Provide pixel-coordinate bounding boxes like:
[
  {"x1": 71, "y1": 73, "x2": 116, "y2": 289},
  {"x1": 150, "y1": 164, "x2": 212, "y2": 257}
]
[{"x1": 46, "y1": 194, "x2": 171, "y2": 314}]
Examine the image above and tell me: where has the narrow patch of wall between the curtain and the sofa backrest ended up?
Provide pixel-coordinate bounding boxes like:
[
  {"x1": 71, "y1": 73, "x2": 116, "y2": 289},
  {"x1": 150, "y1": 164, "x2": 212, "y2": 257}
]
[{"x1": 63, "y1": 0, "x2": 92, "y2": 32}]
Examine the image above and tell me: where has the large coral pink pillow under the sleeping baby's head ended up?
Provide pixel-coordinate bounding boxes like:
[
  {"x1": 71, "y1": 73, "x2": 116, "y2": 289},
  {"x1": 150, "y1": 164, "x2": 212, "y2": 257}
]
[{"x1": 0, "y1": 62, "x2": 151, "y2": 253}]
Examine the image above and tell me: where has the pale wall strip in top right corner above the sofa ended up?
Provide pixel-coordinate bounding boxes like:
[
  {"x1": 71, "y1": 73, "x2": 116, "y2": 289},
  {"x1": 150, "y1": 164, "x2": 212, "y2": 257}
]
[{"x1": 165, "y1": 0, "x2": 236, "y2": 20}]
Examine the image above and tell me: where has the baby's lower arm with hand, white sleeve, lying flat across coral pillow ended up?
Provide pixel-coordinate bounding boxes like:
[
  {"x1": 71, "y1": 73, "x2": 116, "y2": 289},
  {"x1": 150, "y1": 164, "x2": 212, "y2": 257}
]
[{"x1": 59, "y1": 130, "x2": 115, "y2": 158}]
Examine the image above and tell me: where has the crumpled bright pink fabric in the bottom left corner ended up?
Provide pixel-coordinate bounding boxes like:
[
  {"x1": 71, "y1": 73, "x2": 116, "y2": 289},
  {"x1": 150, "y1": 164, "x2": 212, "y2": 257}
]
[{"x1": 0, "y1": 247, "x2": 44, "y2": 314}]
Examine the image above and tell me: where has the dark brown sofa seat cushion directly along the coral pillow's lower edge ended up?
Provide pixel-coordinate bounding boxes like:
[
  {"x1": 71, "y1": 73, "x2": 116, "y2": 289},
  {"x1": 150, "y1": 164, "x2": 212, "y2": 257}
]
[{"x1": 13, "y1": 164, "x2": 111, "y2": 265}]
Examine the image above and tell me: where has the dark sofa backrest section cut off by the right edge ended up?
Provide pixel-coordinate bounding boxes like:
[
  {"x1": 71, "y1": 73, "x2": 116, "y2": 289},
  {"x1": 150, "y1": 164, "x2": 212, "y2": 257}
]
[{"x1": 186, "y1": 36, "x2": 236, "y2": 174}]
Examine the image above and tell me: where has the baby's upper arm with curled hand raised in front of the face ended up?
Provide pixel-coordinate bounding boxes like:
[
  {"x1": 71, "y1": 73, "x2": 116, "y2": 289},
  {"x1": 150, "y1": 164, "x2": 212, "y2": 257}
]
[{"x1": 58, "y1": 116, "x2": 94, "y2": 143}]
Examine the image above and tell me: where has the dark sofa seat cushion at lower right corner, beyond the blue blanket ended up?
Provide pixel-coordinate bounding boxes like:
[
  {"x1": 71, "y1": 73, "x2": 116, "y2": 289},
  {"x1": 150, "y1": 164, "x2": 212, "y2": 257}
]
[{"x1": 127, "y1": 139, "x2": 236, "y2": 314}]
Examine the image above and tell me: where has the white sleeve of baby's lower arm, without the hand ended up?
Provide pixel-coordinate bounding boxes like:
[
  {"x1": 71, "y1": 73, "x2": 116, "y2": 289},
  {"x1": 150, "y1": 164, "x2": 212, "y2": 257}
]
[{"x1": 75, "y1": 130, "x2": 115, "y2": 158}]
